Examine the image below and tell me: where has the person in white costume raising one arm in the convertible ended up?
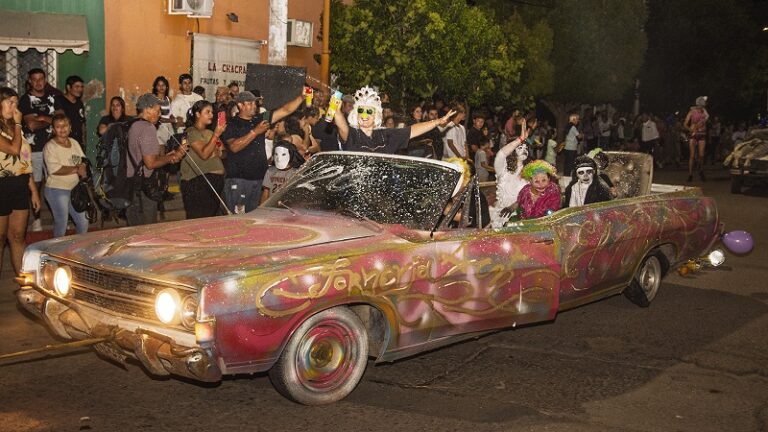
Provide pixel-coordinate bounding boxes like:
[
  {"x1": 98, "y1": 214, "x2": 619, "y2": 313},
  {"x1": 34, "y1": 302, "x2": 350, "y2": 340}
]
[{"x1": 490, "y1": 120, "x2": 528, "y2": 228}]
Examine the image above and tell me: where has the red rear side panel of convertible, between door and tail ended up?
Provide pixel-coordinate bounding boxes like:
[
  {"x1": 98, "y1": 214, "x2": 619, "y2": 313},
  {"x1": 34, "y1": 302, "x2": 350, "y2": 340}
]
[{"x1": 552, "y1": 192, "x2": 718, "y2": 308}]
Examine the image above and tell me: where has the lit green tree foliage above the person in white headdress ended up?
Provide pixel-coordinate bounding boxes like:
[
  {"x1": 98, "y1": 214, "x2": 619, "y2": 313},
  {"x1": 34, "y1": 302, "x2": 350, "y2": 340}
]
[{"x1": 331, "y1": 0, "x2": 524, "y2": 107}]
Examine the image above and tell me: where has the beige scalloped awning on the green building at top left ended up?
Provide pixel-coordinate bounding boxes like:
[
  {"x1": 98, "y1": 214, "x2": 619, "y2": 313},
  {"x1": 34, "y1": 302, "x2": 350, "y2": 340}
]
[{"x1": 0, "y1": 9, "x2": 89, "y2": 54}]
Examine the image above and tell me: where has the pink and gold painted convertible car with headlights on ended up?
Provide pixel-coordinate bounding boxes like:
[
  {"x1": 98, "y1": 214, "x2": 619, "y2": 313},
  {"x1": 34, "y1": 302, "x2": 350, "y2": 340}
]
[{"x1": 17, "y1": 152, "x2": 722, "y2": 405}]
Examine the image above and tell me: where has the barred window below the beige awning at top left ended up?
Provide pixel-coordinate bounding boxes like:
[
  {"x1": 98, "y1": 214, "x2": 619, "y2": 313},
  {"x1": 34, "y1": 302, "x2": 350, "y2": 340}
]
[{"x1": 0, "y1": 48, "x2": 56, "y2": 95}]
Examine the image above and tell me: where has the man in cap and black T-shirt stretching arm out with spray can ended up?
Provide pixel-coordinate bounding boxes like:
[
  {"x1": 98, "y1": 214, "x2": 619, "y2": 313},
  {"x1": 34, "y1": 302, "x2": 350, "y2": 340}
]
[{"x1": 221, "y1": 91, "x2": 304, "y2": 212}]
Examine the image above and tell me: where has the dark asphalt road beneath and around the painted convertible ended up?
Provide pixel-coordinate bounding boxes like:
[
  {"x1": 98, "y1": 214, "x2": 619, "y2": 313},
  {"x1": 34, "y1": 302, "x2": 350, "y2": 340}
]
[{"x1": 0, "y1": 166, "x2": 768, "y2": 432}]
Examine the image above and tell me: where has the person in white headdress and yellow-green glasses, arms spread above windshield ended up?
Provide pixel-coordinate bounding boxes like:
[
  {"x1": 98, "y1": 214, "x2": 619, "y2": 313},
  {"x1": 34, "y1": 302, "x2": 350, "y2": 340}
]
[{"x1": 334, "y1": 86, "x2": 455, "y2": 154}]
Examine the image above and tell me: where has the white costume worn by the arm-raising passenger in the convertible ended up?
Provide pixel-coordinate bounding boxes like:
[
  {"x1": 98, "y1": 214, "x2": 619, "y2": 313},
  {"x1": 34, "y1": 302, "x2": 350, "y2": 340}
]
[{"x1": 490, "y1": 139, "x2": 528, "y2": 228}]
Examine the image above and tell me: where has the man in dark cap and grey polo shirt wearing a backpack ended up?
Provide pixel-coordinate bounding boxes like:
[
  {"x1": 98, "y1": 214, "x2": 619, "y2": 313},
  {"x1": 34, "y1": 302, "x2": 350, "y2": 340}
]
[{"x1": 125, "y1": 93, "x2": 187, "y2": 226}]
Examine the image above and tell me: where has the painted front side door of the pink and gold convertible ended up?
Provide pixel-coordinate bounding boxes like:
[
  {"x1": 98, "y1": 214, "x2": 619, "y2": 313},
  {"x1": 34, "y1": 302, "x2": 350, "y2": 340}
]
[{"x1": 431, "y1": 181, "x2": 560, "y2": 340}]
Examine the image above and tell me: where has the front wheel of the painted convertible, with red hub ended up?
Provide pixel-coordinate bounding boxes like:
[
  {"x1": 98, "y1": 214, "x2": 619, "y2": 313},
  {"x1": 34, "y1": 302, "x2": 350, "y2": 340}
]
[{"x1": 269, "y1": 307, "x2": 368, "y2": 405}]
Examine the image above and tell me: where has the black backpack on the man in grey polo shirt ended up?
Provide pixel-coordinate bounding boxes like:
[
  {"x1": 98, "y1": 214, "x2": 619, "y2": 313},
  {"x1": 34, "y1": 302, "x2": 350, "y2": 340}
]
[{"x1": 95, "y1": 118, "x2": 142, "y2": 210}]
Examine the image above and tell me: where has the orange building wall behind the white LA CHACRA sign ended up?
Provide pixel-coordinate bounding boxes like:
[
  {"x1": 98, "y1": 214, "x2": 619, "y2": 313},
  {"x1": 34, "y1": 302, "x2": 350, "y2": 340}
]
[{"x1": 104, "y1": 0, "x2": 323, "y2": 114}]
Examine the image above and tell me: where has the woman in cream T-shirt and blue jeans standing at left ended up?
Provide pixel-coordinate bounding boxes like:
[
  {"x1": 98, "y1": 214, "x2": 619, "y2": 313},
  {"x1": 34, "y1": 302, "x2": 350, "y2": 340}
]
[{"x1": 43, "y1": 113, "x2": 88, "y2": 237}]
